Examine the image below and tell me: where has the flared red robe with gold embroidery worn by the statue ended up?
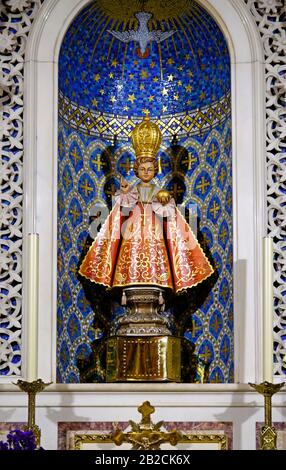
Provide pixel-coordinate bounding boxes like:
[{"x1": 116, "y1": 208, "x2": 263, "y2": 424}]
[{"x1": 79, "y1": 189, "x2": 214, "y2": 293}]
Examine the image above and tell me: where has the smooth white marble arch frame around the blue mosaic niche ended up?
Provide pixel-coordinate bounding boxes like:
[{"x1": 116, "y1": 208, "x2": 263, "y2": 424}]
[{"x1": 23, "y1": 0, "x2": 265, "y2": 391}]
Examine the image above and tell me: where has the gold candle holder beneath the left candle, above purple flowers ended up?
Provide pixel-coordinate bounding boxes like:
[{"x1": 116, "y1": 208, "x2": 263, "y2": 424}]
[{"x1": 14, "y1": 379, "x2": 52, "y2": 448}]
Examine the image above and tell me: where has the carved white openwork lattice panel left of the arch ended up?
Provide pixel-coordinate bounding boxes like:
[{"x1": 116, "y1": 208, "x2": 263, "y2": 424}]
[{"x1": 0, "y1": 0, "x2": 43, "y2": 376}]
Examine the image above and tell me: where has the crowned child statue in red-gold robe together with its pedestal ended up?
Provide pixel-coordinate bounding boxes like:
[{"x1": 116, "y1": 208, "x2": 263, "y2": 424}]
[{"x1": 79, "y1": 117, "x2": 213, "y2": 381}]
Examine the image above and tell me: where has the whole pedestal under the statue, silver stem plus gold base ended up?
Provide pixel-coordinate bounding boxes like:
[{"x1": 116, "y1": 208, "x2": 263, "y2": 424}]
[{"x1": 106, "y1": 286, "x2": 181, "y2": 382}]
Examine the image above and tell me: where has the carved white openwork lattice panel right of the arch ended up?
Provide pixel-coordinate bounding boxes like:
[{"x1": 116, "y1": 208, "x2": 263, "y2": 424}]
[{"x1": 244, "y1": 0, "x2": 286, "y2": 376}]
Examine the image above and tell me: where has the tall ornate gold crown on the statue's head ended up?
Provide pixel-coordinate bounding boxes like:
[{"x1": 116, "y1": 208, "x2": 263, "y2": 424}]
[{"x1": 131, "y1": 116, "x2": 162, "y2": 160}]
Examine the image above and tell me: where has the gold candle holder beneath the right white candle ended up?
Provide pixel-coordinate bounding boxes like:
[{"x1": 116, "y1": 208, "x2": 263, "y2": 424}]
[{"x1": 249, "y1": 381, "x2": 285, "y2": 450}]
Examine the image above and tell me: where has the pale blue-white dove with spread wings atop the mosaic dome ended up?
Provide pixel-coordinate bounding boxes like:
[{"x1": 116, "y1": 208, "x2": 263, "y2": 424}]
[{"x1": 108, "y1": 11, "x2": 176, "y2": 57}]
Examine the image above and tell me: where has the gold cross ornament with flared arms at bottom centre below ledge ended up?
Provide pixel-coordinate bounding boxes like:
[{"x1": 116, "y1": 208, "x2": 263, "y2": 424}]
[{"x1": 111, "y1": 401, "x2": 181, "y2": 450}]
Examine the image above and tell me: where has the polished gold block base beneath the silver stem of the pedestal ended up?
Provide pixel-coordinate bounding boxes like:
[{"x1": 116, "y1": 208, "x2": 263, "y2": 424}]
[{"x1": 106, "y1": 335, "x2": 181, "y2": 382}]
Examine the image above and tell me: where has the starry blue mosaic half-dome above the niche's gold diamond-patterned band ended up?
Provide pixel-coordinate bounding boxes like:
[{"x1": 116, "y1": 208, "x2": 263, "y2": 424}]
[{"x1": 59, "y1": 2, "x2": 230, "y2": 119}]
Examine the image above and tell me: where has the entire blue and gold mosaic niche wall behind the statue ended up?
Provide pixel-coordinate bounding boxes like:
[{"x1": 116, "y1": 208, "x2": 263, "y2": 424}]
[{"x1": 57, "y1": 0, "x2": 233, "y2": 383}]
